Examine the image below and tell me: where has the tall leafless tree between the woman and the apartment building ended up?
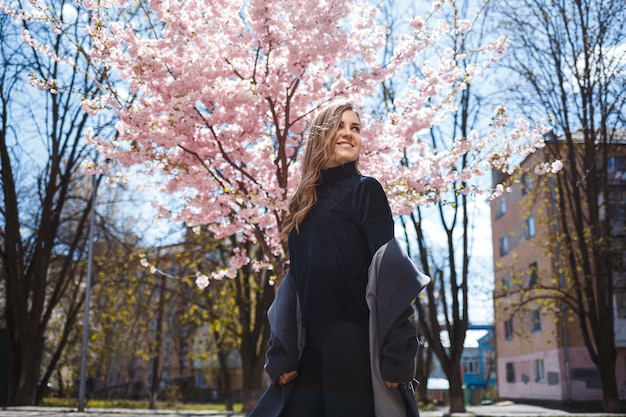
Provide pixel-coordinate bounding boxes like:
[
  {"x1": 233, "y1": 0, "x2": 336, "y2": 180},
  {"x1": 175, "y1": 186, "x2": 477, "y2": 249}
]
[{"x1": 381, "y1": 0, "x2": 502, "y2": 412}]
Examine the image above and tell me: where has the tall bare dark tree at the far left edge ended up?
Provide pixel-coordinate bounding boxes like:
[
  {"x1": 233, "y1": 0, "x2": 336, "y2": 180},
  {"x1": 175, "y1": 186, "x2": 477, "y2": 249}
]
[{"x1": 0, "y1": 1, "x2": 114, "y2": 405}]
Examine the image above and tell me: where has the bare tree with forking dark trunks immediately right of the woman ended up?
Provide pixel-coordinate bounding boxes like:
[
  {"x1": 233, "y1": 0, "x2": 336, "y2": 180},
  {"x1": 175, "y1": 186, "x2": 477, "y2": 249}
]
[{"x1": 372, "y1": 1, "x2": 500, "y2": 413}]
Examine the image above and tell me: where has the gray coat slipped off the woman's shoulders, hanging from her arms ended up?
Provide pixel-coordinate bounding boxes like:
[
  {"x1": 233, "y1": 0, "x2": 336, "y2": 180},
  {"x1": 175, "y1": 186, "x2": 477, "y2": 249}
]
[{"x1": 248, "y1": 239, "x2": 430, "y2": 417}]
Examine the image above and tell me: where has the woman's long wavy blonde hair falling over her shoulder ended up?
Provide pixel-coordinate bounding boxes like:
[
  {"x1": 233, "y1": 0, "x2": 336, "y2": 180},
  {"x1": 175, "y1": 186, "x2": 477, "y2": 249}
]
[{"x1": 281, "y1": 101, "x2": 360, "y2": 239}]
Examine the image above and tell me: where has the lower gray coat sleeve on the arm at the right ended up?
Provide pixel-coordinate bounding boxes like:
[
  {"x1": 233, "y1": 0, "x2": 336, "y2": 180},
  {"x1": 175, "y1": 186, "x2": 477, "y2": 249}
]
[{"x1": 381, "y1": 307, "x2": 419, "y2": 382}]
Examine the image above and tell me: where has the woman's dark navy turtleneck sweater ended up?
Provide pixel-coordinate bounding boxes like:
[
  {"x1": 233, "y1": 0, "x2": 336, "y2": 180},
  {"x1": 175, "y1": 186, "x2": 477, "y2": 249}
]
[{"x1": 289, "y1": 162, "x2": 394, "y2": 323}]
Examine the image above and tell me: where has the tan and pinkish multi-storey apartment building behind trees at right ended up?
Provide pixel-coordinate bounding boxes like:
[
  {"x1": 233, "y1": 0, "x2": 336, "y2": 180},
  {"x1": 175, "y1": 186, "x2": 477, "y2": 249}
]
[{"x1": 491, "y1": 135, "x2": 626, "y2": 403}]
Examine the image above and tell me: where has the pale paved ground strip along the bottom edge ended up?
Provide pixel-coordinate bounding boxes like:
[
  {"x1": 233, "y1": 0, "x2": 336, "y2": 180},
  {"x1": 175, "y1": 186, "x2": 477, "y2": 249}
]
[{"x1": 0, "y1": 402, "x2": 626, "y2": 417}]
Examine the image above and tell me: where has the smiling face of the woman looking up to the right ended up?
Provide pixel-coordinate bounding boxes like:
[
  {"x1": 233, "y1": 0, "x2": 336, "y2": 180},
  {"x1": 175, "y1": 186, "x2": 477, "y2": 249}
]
[{"x1": 324, "y1": 110, "x2": 361, "y2": 169}]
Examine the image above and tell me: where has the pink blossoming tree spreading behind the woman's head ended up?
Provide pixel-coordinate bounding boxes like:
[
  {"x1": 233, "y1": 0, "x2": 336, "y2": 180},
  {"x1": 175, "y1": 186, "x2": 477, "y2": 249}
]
[{"x1": 62, "y1": 0, "x2": 543, "y2": 285}]
